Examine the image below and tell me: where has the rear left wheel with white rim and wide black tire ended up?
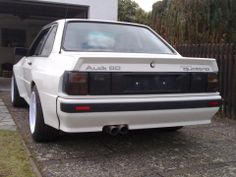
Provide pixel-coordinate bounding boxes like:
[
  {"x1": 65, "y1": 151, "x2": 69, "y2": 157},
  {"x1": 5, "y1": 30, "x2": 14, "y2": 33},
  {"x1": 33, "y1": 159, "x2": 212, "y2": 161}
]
[{"x1": 29, "y1": 87, "x2": 59, "y2": 142}]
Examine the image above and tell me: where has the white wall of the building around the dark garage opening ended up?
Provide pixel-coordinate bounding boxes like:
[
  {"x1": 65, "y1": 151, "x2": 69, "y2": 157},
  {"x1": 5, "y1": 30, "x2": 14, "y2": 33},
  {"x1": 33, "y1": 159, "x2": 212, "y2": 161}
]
[{"x1": 27, "y1": 0, "x2": 118, "y2": 21}]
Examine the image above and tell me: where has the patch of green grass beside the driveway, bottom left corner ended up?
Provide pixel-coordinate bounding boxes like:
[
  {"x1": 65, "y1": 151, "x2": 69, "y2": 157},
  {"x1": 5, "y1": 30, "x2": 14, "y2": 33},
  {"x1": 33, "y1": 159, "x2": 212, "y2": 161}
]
[{"x1": 0, "y1": 130, "x2": 36, "y2": 177}]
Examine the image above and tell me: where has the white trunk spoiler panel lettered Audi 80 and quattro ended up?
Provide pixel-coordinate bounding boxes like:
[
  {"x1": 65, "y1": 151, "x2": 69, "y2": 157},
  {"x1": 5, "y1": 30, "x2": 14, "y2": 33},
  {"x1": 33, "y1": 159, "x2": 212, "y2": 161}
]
[{"x1": 71, "y1": 54, "x2": 218, "y2": 72}]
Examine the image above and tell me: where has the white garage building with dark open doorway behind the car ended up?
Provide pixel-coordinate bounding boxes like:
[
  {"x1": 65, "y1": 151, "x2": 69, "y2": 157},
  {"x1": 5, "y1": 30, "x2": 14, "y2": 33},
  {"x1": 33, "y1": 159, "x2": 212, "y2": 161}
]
[{"x1": 0, "y1": 0, "x2": 118, "y2": 76}]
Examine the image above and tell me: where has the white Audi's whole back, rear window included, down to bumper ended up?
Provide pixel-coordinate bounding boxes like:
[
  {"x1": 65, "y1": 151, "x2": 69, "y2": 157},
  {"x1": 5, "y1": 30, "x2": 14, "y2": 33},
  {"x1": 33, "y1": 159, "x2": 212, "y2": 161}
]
[{"x1": 57, "y1": 21, "x2": 221, "y2": 132}]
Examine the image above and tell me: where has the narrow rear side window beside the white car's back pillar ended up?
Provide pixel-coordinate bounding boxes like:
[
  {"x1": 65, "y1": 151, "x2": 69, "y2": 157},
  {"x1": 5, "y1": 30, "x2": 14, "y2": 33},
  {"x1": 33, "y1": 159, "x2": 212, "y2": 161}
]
[{"x1": 41, "y1": 26, "x2": 57, "y2": 56}]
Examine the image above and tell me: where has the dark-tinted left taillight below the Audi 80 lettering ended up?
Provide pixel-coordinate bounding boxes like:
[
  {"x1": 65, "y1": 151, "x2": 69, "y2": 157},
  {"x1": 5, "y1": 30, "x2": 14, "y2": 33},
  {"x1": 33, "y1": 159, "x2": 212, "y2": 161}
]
[{"x1": 63, "y1": 72, "x2": 88, "y2": 95}]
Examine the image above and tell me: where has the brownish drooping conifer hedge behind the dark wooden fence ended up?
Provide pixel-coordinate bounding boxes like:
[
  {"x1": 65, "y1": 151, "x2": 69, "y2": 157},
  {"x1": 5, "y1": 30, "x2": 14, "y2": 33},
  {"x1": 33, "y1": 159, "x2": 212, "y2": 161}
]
[{"x1": 151, "y1": 0, "x2": 236, "y2": 44}]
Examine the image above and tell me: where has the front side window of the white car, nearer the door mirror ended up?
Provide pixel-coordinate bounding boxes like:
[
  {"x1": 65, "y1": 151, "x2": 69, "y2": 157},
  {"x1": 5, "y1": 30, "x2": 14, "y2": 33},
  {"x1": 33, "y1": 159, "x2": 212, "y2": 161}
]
[{"x1": 28, "y1": 28, "x2": 50, "y2": 56}]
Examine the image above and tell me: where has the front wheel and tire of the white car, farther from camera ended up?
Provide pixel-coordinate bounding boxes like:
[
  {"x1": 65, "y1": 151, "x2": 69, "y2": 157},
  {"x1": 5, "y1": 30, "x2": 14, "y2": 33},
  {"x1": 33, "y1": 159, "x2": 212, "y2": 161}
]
[{"x1": 11, "y1": 75, "x2": 27, "y2": 107}]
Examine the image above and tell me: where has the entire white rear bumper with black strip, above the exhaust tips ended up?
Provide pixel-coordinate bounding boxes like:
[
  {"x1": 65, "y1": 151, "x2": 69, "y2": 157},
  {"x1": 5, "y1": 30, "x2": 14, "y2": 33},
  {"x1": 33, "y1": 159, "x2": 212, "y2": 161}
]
[{"x1": 57, "y1": 94, "x2": 221, "y2": 132}]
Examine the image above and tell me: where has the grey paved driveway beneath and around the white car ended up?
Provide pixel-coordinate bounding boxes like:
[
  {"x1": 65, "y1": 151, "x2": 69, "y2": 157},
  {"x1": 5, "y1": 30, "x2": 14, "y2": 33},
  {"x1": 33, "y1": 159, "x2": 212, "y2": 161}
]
[{"x1": 0, "y1": 92, "x2": 236, "y2": 177}]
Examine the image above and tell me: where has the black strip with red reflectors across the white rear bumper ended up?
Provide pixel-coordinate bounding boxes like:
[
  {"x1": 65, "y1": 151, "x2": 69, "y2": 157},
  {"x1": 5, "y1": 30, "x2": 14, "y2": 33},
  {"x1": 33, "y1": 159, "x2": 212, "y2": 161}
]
[{"x1": 60, "y1": 99, "x2": 221, "y2": 113}]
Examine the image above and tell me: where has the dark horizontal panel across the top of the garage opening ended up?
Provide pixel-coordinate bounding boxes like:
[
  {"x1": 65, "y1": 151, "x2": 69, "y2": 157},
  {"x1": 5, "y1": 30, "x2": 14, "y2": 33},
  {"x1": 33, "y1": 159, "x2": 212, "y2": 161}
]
[{"x1": 0, "y1": 0, "x2": 89, "y2": 20}]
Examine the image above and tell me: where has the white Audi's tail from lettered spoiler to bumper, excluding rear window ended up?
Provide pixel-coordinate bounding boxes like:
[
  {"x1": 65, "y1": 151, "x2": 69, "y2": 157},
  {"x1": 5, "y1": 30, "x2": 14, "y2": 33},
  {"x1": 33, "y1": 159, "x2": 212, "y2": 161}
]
[{"x1": 57, "y1": 56, "x2": 221, "y2": 132}]
